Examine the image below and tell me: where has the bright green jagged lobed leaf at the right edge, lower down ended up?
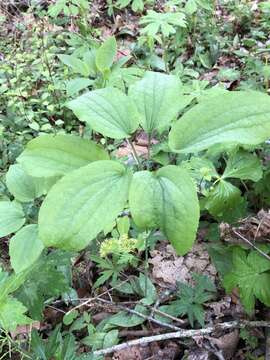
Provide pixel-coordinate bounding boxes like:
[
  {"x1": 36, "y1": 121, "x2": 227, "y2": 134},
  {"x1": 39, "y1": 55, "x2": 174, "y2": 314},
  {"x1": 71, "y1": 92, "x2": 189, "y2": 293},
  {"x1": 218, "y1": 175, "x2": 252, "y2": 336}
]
[{"x1": 223, "y1": 247, "x2": 270, "y2": 313}]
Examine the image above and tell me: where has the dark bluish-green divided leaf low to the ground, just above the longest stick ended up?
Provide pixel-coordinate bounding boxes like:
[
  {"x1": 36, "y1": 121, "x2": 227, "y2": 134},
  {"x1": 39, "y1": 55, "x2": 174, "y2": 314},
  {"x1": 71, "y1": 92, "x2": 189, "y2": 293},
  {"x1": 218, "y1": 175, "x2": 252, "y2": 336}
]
[{"x1": 156, "y1": 274, "x2": 216, "y2": 327}]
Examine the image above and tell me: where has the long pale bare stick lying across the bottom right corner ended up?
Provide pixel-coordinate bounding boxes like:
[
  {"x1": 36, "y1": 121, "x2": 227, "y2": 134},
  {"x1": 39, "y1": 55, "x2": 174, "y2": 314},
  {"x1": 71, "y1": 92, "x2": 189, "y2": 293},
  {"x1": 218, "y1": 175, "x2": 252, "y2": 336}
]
[{"x1": 93, "y1": 321, "x2": 270, "y2": 356}]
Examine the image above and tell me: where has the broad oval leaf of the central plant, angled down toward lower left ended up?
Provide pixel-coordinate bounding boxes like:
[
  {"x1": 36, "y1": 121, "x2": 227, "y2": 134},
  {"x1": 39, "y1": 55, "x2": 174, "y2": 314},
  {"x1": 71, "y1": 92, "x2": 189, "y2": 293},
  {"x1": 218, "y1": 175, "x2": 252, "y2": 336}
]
[{"x1": 39, "y1": 161, "x2": 131, "y2": 251}]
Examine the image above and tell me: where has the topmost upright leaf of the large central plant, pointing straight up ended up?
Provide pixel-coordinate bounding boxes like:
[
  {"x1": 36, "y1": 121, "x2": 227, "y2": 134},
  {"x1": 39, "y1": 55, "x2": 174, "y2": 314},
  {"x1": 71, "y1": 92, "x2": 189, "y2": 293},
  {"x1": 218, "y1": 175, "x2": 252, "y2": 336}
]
[{"x1": 129, "y1": 71, "x2": 193, "y2": 134}]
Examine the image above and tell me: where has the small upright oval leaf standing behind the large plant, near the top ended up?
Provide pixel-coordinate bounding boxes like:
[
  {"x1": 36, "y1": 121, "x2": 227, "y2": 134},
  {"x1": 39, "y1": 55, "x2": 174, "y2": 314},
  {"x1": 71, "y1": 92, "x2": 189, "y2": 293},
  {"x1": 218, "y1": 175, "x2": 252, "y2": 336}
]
[{"x1": 96, "y1": 36, "x2": 117, "y2": 72}]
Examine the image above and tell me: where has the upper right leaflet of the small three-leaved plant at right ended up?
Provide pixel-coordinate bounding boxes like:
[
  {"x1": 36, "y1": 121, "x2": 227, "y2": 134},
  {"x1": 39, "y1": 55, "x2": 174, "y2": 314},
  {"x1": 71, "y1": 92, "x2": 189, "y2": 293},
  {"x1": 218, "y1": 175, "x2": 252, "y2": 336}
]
[{"x1": 222, "y1": 150, "x2": 263, "y2": 181}]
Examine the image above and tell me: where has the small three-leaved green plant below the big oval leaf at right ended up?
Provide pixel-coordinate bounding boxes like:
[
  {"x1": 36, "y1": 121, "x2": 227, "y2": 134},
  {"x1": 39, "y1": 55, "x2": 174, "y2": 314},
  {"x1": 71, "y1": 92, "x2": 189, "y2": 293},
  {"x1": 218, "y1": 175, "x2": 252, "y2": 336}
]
[{"x1": 182, "y1": 147, "x2": 263, "y2": 222}]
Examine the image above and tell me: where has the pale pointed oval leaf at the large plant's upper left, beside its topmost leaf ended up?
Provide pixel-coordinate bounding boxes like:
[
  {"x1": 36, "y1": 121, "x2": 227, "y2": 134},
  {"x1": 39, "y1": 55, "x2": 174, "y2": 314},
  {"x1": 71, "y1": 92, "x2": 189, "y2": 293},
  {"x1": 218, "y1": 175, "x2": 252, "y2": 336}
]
[{"x1": 68, "y1": 87, "x2": 139, "y2": 139}]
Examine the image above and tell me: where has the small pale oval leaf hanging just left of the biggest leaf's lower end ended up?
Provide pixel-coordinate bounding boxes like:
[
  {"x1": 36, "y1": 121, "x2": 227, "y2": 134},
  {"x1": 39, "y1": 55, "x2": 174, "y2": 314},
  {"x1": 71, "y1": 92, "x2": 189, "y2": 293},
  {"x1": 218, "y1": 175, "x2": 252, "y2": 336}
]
[{"x1": 9, "y1": 225, "x2": 44, "y2": 273}]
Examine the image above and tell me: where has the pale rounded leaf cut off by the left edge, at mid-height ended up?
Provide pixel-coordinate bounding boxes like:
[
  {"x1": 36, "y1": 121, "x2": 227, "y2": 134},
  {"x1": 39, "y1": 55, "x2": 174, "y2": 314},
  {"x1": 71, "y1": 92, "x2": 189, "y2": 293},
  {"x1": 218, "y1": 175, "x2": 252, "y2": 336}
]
[{"x1": 0, "y1": 201, "x2": 25, "y2": 237}]
